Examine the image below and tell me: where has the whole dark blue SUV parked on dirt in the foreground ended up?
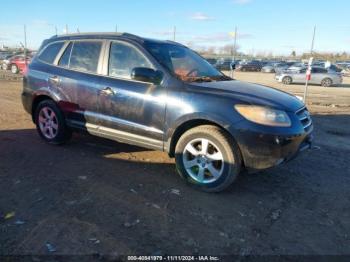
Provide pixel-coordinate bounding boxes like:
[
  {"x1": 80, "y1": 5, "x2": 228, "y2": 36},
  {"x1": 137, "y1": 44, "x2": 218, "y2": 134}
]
[{"x1": 22, "y1": 33, "x2": 313, "y2": 192}]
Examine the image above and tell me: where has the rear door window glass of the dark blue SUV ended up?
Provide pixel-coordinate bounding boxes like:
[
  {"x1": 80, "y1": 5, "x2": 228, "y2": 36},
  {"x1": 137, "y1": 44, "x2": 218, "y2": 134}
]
[{"x1": 69, "y1": 41, "x2": 102, "y2": 73}]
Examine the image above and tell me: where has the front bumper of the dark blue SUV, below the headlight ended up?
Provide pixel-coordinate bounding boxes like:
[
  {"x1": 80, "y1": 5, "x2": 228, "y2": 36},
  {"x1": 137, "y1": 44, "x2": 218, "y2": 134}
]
[{"x1": 238, "y1": 129, "x2": 313, "y2": 172}]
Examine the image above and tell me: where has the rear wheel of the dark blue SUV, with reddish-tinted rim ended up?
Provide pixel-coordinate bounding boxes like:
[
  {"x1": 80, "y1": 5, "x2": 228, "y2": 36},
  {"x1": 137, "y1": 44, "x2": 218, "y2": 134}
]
[{"x1": 34, "y1": 100, "x2": 72, "y2": 145}]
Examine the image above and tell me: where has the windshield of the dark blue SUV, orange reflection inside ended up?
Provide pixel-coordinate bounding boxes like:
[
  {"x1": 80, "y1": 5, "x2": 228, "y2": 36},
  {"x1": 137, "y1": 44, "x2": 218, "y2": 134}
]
[{"x1": 145, "y1": 43, "x2": 231, "y2": 82}]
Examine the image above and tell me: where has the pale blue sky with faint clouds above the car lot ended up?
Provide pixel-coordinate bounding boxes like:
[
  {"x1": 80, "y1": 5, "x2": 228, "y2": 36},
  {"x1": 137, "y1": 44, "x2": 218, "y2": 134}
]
[{"x1": 0, "y1": 0, "x2": 350, "y2": 55}]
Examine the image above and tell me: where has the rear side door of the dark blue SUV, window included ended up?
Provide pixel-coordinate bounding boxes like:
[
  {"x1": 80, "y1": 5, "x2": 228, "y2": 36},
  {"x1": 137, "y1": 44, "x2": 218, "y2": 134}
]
[{"x1": 53, "y1": 40, "x2": 104, "y2": 130}]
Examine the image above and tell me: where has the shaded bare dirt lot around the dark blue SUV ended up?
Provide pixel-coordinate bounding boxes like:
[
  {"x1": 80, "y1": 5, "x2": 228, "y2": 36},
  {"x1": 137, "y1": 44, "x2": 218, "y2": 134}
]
[{"x1": 0, "y1": 70, "x2": 350, "y2": 256}]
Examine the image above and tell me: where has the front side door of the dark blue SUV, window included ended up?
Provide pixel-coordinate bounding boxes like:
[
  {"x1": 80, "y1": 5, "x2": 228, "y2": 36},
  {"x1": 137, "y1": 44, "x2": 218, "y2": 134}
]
[{"x1": 99, "y1": 41, "x2": 166, "y2": 149}]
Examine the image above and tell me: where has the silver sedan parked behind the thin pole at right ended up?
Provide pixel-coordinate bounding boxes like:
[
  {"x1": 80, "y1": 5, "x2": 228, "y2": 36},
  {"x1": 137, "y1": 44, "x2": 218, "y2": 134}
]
[{"x1": 276, "y1": 67, "x2": 343, "y2": 87}]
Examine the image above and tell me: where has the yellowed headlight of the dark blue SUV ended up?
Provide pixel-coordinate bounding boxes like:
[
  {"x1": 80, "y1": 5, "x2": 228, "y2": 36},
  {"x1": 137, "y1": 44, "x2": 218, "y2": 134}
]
[{"x1": 235, "y1": 105, "x2": 291, "y2": 127}]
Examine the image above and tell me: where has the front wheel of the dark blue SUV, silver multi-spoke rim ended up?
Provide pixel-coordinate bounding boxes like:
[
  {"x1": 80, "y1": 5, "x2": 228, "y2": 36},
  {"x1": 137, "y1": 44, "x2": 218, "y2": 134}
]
[{"x1": 175, "y1": 125, "x2": 242, "y2": 192}]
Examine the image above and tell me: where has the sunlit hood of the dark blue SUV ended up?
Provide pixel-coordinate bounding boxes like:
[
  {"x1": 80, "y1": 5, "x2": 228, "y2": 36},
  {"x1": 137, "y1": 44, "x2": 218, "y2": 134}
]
[{"x1": 189, "y1": 80, "x2": 304, "y2": 112}]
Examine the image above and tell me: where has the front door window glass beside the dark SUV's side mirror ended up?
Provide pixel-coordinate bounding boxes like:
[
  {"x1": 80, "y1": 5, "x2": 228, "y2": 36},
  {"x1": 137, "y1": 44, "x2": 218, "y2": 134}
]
[{"x1": 108, "y1": 42, "x2": 153, "y2": 79}]
